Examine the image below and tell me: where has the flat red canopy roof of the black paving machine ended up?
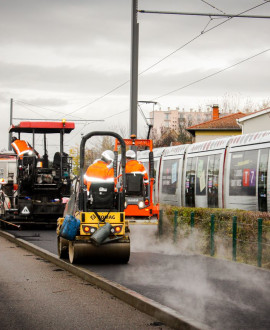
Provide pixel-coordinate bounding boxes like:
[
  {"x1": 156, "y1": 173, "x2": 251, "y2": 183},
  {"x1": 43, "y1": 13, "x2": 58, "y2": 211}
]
[{"x1": 9, "y1": 121, "x2": 75, "y2": 134}]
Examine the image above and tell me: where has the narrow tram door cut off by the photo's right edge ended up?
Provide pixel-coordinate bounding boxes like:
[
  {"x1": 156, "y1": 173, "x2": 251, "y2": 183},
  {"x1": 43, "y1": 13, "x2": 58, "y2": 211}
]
[{"x1": 258, "y1": 149, "x2": 269, "y2": 212}]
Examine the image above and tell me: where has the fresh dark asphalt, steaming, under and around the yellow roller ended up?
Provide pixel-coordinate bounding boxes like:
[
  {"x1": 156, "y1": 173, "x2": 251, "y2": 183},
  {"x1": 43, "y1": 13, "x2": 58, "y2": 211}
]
[{"x1": 5, "y1": 225, "x2": 270, "y2": 329}]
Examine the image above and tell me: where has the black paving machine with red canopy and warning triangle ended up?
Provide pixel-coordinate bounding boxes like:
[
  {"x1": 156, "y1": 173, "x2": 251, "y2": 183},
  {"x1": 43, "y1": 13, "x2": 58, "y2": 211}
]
[{"x1": 0, "y1": 120, "x2": 75, "y2": 224}]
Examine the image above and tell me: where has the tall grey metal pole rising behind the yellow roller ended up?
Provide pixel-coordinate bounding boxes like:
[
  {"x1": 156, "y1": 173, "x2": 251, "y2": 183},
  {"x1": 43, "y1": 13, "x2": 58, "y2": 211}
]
[{"x1": 129, "y1": 0, "x2": 139, "y2": 135}]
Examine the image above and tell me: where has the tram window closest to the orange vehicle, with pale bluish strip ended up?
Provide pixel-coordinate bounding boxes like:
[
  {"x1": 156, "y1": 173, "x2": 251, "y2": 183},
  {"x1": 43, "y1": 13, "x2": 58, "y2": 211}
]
[{"x1": 162, "y1": 159, "x2": 179, "y2": 195}]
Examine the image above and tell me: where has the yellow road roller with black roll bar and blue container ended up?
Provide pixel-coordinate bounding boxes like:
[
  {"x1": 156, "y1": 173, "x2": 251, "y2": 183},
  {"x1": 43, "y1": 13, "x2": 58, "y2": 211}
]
[{"x1": 56, "y1": 131, "x2": 130, "y2": 263}]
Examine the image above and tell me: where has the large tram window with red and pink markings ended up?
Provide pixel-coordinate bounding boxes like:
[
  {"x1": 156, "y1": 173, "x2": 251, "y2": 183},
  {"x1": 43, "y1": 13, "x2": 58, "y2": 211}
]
[{"x1": 229, "y1": 150, "x2": 258, "y2": 196}]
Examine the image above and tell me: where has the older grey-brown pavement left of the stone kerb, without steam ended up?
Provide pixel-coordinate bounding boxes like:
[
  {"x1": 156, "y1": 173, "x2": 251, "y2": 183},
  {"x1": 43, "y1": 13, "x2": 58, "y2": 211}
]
[{"x1": 0, "y1": 237, "x2": 169, "y2": 330}]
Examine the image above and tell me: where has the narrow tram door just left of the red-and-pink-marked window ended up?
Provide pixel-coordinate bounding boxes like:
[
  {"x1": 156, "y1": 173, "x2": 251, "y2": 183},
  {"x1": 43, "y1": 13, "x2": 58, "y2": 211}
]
[{"x1": 207, "y1": 155, "x2": 220, "y2": 208}]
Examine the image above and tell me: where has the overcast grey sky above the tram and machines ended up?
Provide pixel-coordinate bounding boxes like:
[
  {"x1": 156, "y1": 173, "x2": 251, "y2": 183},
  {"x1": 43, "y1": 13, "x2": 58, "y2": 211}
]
[{"x1": 0, "y1": 0, "x2": 270, "y2": 149}]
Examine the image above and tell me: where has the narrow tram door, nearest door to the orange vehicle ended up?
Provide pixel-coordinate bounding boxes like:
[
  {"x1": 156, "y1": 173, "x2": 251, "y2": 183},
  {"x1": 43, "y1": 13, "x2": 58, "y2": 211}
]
[{"x1": 185, "y1": 157, "x2": 197, "y2": 207}]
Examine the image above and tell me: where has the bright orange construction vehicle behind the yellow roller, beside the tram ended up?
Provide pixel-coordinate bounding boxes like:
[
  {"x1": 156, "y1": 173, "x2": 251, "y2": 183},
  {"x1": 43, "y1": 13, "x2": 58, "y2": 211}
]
[{"x1": 115, "y1": 135, "x2": 159, "y2": 222}]
